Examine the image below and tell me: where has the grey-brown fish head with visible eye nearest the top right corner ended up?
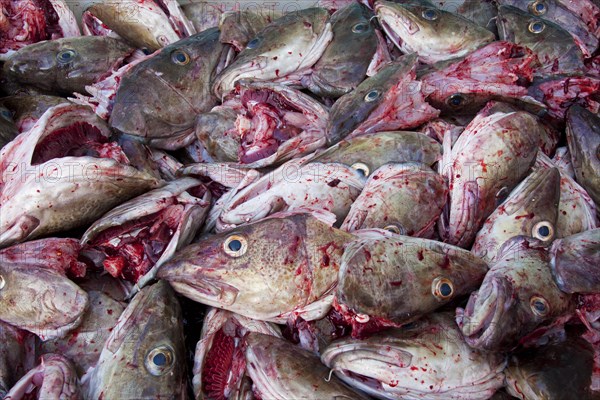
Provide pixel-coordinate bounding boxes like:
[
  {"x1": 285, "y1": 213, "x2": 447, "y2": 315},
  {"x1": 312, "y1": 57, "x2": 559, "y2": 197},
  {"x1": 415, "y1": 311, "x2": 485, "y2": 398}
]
[{"x1": 497, "y1": 6, "x2": 585, "y2": 75}]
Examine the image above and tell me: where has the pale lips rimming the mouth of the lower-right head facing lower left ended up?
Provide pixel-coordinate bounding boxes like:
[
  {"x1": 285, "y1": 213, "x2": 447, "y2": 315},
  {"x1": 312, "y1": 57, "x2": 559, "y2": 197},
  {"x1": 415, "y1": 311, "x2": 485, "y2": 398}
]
[{"x1": 457, "y1": 279, "x2": 510, "y2": 347}]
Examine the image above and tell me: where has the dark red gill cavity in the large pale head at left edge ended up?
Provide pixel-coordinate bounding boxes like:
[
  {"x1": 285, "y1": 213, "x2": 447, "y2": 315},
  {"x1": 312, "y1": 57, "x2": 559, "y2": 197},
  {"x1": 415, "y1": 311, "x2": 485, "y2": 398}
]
[{"x1": 31, "y1": 122, "x2": 129, "y2": 165}]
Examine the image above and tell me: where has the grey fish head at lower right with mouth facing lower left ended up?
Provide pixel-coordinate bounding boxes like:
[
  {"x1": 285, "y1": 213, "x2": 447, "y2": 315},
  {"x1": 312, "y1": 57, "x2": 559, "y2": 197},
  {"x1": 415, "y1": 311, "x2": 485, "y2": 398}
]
[{"x1": 456, "y1": 236, "x2": 575, "y2": 351}]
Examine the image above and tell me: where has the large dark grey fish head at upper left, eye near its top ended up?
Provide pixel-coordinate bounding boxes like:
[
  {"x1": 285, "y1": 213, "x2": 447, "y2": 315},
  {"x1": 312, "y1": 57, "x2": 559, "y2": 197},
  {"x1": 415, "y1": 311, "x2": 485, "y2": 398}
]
[{"x1": 109, "y1": 28, "x2": 229, "y2": 150}]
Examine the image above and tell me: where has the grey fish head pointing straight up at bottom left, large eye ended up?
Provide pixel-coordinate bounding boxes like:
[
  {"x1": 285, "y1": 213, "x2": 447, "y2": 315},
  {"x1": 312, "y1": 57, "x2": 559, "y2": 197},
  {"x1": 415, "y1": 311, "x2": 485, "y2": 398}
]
[{"x1": 83, "y1": 281, "x2": 187, "y2": 400}]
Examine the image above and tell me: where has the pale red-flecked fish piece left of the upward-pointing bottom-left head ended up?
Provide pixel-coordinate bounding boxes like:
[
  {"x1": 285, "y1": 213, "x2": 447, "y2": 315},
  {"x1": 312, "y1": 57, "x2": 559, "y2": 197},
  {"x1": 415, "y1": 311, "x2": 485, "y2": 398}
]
[{"x1": 38, "y1": 291, "x2": 125, "y2": 376}]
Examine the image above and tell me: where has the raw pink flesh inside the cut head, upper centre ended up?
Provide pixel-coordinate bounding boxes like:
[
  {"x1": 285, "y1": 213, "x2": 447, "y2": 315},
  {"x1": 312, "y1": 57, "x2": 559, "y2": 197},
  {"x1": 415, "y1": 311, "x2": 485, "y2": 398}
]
[{"x1": 238, "y1": 90, "x2": 302, "y2": 164}]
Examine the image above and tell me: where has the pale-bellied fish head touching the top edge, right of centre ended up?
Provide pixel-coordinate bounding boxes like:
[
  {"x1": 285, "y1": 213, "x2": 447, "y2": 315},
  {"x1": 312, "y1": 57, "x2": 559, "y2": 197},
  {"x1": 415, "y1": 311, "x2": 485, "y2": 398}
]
[{"x1": 375, "y1": 0, "x2": 495, "y2": 64}]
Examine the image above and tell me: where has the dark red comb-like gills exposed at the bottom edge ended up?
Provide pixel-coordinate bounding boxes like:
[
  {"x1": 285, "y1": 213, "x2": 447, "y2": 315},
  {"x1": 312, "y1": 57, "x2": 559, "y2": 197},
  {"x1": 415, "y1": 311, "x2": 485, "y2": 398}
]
[{"x1": 202, "y1": 328, "x2": 246, "y2": 400}]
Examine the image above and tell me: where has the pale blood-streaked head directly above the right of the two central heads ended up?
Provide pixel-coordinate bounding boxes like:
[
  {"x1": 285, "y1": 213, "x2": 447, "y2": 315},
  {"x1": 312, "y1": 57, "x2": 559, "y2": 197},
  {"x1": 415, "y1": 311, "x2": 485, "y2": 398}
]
[{"x1": 340, "y1": 163, "x2": 448, "y2": 238}]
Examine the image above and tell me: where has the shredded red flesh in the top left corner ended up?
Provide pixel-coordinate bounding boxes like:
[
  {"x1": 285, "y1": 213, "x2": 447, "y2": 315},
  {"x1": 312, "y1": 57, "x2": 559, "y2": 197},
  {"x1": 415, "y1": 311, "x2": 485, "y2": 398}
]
[{"x1": 0, "y1": 0, "x2": 63, "y2": 53}]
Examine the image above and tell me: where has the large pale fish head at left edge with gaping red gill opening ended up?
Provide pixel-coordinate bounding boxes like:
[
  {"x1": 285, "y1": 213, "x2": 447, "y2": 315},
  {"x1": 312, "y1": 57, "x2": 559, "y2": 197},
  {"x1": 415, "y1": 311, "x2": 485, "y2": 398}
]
[{"x1": 0, "y1": 104, "x2": 160, "y2": 247}]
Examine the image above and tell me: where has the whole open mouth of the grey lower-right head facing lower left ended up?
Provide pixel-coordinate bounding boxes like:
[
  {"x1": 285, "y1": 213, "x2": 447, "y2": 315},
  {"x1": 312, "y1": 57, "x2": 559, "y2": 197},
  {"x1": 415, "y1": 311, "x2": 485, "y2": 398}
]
[{"x1": 456, "y1": 279, "x2": 512, "y2": 346}]
